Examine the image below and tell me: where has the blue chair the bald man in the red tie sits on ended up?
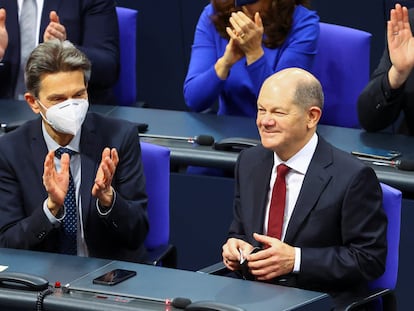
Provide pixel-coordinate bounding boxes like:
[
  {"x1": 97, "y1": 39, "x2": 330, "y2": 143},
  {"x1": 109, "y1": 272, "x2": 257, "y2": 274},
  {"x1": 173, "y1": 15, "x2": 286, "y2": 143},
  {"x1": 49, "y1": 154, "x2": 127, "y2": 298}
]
[{"x1": 345, "y1": 183, "x2": 402, "y2": 311}]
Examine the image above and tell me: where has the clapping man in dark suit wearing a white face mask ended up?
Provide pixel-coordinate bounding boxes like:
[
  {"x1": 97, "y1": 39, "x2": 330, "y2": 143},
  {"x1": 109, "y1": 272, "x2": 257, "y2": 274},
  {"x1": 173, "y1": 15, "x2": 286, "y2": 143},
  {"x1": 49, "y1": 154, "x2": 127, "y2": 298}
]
[{"x1": 0, "y1": 40, "x2": 148, "y2": 261}]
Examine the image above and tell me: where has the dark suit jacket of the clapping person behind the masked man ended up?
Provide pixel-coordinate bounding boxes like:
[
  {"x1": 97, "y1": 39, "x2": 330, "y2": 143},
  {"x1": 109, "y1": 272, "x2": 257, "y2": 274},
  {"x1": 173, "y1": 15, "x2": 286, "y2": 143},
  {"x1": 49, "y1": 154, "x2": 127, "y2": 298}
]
[{"x1": 0, "y1": 0, "x2": 119, "y2": 104}]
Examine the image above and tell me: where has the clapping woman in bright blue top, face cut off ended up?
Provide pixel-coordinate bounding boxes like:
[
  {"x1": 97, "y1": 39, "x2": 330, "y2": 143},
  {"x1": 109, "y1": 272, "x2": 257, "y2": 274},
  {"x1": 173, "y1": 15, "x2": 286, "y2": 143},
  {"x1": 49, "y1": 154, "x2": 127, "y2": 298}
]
[{"x1": 184, "y1": 0, "x2": 319, "y2": 117}]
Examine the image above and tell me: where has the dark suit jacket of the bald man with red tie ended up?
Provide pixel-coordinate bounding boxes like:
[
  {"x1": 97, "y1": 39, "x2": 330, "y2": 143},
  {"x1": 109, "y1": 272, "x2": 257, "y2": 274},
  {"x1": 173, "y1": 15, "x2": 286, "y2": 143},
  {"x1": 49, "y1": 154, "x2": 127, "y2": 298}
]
[{"x1": 229, "y1": 137, "x2": 387, "y2": 306}]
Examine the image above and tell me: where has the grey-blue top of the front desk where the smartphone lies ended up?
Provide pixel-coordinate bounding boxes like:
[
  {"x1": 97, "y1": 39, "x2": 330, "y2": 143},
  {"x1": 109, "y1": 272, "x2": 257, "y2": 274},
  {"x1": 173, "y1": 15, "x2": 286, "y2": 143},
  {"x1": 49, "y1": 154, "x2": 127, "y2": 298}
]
[{"x1": 0, "y1": 248, "x2": 331, "y2": 311}]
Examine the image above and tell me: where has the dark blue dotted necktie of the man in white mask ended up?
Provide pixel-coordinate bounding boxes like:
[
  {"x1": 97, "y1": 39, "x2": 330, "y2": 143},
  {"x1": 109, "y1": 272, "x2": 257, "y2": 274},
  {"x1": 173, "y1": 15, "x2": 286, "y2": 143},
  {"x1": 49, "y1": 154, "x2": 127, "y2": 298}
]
[{"x1": 55, "y1": 147, "x2": 77, "y2": 255}]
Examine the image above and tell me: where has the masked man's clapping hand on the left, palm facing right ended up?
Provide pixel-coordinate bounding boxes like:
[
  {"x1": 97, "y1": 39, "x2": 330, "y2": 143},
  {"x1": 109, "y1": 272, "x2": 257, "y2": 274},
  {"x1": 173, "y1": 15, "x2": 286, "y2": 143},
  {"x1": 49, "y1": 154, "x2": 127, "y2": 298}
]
[{"x1": 43, "y1": 151, "x2": 70, "y2": 216}]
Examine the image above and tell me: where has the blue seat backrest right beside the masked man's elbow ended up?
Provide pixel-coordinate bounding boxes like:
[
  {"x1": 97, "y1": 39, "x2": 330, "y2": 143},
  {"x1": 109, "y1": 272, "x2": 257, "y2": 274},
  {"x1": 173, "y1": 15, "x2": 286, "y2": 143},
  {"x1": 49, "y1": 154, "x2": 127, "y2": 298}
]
[{"x1": 140, "y1": 142, "x2": 170, "y2": 249}]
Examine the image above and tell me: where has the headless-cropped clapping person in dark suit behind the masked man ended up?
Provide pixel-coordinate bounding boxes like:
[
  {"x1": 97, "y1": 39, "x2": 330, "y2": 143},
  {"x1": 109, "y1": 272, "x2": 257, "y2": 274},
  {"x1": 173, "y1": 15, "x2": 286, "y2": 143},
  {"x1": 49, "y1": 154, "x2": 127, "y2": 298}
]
[{"x1": 0, "y1": 0, "x2": 119, "y2": 104}]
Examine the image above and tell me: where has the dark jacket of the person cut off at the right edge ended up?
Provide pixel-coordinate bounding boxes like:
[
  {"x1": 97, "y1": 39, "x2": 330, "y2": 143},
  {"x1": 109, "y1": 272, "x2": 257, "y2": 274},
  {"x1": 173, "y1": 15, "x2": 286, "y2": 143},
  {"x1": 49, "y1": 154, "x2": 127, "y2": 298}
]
[{"x1": 358, "y1": 9, "x2": 414, "y2": 135}]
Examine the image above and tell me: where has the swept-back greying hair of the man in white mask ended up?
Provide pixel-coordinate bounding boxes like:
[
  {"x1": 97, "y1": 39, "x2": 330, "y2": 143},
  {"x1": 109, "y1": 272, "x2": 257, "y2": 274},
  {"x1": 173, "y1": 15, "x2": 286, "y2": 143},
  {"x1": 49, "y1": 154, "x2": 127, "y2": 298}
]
[{"x1": 24, "y1": 39, "x2": 91, "y2": 97}]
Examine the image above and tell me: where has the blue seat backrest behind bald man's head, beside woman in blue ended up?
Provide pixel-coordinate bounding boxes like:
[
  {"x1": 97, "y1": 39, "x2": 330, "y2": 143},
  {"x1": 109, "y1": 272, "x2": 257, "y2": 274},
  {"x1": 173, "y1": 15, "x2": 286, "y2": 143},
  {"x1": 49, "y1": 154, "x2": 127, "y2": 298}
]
[{"x1": 312, "y1": 22, "x2": 372, "y2": 128}]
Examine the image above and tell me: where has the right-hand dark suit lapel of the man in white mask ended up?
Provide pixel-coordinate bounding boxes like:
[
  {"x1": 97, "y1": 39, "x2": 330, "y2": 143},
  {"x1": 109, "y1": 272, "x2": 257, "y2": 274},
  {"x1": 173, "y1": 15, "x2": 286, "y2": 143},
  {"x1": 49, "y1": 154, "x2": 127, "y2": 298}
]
[{"x1": 80, "y1": 116, "x2": 102, "y2": 226}]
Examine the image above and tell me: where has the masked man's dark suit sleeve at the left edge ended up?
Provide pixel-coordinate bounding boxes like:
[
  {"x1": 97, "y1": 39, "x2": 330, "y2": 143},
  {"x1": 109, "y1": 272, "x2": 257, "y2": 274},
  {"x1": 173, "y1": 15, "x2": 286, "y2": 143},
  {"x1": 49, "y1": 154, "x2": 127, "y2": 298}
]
[{"x1": 0, "y1": 133, "x2": 54, "y2": 250}]
